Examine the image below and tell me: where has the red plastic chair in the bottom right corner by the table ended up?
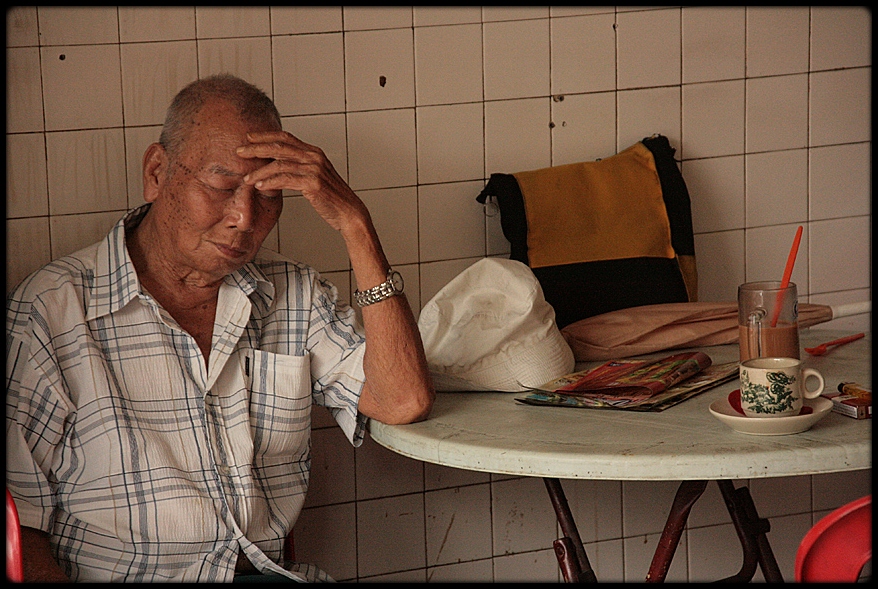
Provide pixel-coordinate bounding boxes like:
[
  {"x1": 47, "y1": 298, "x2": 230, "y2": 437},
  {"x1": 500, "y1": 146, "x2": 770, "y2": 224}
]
[{"x1": 796, "y1": 495, "x2": 872, "y2": 583}]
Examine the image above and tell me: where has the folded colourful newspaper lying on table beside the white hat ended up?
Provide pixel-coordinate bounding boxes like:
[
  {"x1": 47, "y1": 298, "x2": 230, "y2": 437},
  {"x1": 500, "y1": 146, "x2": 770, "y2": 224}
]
[{"x1": 515, "y1": 352, "x2": 738, "y2": 411}]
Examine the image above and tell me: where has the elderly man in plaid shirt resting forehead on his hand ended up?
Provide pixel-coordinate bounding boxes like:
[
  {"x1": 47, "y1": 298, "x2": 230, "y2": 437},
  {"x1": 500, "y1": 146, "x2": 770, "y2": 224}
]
[{"x1": 6, "y1": 75, "x2": 434, "y2": 582}]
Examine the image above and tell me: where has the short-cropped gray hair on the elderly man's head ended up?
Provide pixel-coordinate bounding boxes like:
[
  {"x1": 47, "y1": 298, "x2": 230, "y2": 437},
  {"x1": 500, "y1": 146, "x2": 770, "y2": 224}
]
[{"x1": 159, "y1": 74, "x2": 282, "y2": 159}]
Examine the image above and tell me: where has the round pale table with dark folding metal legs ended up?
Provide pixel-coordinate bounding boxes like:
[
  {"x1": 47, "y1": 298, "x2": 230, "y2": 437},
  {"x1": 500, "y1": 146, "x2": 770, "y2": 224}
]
[{"x1": 370, "y1": 328, "x2": 872, "y2": 579}]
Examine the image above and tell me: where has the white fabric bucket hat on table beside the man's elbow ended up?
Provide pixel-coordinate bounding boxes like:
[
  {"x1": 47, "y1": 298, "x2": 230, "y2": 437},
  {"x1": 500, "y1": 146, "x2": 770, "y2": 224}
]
[{"x1": 418, "y1": 258, "x2": 575, "y2": 392}]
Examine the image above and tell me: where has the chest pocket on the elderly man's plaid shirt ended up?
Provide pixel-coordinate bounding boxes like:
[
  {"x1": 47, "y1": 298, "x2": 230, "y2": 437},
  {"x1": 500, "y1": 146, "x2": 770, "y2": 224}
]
[{"x1": 245, "y1": 350, "x2": 311, "y2": 460}]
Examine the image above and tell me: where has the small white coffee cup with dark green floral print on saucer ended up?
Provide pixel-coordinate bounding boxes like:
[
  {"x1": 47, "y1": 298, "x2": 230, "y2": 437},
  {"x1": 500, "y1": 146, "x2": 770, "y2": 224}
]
[{"x1": 739, "y1": 358, "x2": 824, "y2": 417}]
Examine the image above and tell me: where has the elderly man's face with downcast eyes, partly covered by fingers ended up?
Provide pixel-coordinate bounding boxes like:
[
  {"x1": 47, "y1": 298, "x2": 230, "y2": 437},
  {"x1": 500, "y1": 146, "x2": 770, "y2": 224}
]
[{"x1": 144, "y1": 101, "x2": 283, "y2": 282}]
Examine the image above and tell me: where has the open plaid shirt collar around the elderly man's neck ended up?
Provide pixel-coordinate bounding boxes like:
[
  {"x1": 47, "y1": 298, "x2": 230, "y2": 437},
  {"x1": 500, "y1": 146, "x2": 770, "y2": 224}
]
[{"x1": 86, "y1": 203, "x2": 274, "y2": 321}]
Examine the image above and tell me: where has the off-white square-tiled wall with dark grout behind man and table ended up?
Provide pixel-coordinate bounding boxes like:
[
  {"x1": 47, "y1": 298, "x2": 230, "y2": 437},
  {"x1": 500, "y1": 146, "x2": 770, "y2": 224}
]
[{"x1": 6, "y1": 6, "x2": 872, "y2": 581}]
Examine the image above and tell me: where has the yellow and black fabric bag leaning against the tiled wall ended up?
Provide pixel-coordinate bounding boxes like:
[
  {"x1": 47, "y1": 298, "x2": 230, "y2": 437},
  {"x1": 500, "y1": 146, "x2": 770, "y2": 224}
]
[{"x1": 476, "y1": 135, "x2": 698, "y2": 328}]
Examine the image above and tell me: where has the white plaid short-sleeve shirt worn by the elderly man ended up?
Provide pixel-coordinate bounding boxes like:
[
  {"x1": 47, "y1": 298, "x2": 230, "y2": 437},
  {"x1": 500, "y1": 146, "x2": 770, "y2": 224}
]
[{"x1": 6, "y1": 205, "x2": 366, "y2": 582}]
